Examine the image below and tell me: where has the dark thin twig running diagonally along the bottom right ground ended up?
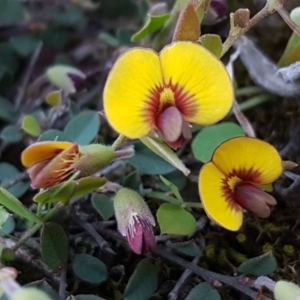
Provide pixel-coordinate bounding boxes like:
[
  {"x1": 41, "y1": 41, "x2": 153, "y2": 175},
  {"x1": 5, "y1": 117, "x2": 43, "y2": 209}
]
[{"x1": 152, "y1": 246, "x2": 271, "y2": 300}]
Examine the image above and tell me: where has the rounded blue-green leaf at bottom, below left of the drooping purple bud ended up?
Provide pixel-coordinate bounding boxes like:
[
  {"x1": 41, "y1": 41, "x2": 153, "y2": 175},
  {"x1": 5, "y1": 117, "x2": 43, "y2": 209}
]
[{"x1": 73, "y1": 254, "x2": 108, "y2": 284}]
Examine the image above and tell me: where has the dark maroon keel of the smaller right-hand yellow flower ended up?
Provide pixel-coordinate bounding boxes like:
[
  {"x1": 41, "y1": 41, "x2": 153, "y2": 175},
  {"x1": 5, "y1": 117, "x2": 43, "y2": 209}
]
[{"x1": 234, "y1": 183, "x2": 277, "y2": 218}]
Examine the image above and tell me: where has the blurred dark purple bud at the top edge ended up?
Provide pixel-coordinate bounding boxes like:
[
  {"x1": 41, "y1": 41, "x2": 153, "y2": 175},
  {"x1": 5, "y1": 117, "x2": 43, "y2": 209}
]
[{"x1": 202, "y1": 0, "x2": 228, "y2": 25}]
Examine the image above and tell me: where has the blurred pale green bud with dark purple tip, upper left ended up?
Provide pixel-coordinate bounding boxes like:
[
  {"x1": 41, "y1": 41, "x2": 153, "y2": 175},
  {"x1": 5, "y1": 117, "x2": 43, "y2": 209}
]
[{"x1": 46, "y1": 65, "x2": 86, "y2": 94}]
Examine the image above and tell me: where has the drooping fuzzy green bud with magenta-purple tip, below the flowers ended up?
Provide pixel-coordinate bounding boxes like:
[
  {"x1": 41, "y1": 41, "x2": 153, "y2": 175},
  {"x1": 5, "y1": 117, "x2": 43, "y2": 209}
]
[{"x1": 114, "y1": 188, "x2": 155, "y2": 254}]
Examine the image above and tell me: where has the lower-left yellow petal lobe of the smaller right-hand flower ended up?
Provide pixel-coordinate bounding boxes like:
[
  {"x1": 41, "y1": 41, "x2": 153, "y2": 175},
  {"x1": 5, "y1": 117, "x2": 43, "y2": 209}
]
[{"x1": 199, "y1": 162, "x2": 243, "y2": 231}]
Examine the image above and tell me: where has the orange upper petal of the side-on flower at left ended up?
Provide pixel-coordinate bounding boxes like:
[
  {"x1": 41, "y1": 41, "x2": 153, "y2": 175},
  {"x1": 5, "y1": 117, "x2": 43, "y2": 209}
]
[{"x1": 21, "y1": 141, "x2": 73, "y2": 168}]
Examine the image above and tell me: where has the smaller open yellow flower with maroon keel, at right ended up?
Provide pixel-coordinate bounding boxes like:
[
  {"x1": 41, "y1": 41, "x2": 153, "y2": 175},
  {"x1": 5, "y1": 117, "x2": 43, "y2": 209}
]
[{"x1": 199, "y1": 137, "x2": 283, "y2": 231}]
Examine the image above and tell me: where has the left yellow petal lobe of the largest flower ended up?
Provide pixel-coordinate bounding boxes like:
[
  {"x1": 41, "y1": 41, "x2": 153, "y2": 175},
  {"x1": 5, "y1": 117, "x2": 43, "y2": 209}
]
[{"x1": 103, "y1": 48, "x2": 163, "y2": 138}]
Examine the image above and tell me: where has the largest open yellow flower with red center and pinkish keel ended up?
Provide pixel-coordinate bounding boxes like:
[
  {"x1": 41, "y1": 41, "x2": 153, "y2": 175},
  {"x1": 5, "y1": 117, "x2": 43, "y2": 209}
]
[{"x1": 103, "y1": 42, "x2": 233, "y2": 148}]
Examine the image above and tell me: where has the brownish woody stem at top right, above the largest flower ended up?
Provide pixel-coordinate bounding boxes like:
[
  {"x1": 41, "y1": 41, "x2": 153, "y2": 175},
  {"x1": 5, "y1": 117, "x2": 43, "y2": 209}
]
[{"x1": 221, "y1": 5, "x2": 273, "y2": 57}]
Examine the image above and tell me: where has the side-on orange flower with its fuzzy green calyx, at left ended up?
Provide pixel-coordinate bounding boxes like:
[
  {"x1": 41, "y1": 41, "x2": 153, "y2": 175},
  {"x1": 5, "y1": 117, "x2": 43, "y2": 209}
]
[{"x1": 21, "y1": 141, "x2": 116, "y2": 188}]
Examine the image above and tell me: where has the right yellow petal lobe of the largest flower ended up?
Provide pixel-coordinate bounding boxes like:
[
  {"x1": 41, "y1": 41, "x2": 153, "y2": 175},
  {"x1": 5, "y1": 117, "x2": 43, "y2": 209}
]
[{"x1": 160, "y1": 42, "x2": 233, "y2": 125}]
